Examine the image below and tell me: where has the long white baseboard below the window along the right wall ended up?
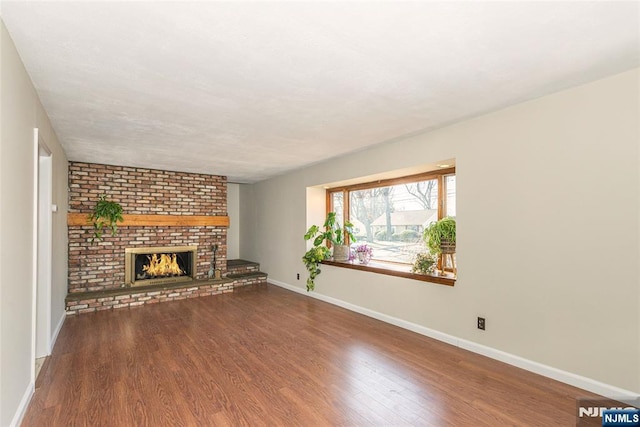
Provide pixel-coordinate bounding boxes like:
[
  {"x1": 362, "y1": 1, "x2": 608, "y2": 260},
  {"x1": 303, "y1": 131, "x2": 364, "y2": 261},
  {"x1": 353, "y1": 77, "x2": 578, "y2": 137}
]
[{"x1": 267, "y1": 279, "x2": 640, "y2": 402}]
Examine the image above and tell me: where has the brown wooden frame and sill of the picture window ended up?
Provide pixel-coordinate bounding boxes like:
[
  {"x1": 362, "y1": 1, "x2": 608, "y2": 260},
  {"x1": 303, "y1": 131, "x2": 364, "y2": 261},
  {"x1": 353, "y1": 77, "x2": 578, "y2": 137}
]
[{"x1": 323, "y1": 167, "x2": 457, "y2": 286}]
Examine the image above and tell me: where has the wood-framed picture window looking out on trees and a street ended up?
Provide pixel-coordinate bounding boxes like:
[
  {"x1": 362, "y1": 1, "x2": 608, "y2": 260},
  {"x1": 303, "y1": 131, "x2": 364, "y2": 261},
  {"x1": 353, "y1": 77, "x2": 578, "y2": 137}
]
[{"x1": 327, "y1": 168, "x2": 456, "y2": 284}]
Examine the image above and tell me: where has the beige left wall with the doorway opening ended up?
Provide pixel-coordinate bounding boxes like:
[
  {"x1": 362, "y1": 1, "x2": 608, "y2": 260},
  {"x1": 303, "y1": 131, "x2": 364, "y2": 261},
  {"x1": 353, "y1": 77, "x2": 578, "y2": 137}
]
[{"x1": 0, "y1": 21, "x2": 67, "y2": 426}]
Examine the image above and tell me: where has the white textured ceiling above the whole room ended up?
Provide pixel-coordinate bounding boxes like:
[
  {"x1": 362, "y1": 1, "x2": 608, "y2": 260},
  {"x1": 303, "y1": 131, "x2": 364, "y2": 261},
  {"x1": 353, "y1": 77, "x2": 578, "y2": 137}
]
[{"x1": 0, "y1": 1, "x2": 640, "y2": 182}]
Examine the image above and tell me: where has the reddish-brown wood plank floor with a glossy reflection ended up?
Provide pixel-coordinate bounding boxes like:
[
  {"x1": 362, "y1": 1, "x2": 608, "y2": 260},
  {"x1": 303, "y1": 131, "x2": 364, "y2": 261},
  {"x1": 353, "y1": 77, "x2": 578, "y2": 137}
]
[{"x1": 23, "y1": 285, "x2": 594, "y2": 426}]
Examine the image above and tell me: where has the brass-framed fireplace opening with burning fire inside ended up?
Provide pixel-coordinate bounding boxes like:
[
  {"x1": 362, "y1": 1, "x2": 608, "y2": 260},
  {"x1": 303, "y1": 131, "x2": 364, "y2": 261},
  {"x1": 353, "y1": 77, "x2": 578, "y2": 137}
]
[{"x1": 125, "y1": 246, "x2": 197, "y2": 286}]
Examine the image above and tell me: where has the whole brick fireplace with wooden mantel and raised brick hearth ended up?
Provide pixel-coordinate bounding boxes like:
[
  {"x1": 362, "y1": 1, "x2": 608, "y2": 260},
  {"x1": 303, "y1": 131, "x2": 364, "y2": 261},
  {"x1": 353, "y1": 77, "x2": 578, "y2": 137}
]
[{"x1": 65, "y1": 161, "x2": 267, "y2": 315}]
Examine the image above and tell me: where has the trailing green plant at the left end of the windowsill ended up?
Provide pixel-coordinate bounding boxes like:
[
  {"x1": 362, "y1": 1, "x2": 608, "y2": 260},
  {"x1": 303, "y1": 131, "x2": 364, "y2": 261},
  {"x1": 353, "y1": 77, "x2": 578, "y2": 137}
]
[{"x1": 302, "y1": 212, "x2": 356, "y2": 292}]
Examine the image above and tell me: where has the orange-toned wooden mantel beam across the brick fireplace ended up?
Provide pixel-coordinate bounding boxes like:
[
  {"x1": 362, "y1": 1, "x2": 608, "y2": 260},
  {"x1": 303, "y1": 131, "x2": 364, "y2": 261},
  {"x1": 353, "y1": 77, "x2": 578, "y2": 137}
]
[{"x1": 67, "y1": 212, "x2": 229, "y2": 227}]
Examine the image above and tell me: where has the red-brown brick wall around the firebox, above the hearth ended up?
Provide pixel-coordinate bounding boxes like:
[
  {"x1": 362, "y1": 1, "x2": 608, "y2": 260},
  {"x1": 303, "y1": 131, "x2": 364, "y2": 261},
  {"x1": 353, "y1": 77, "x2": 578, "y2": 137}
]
[{"x1": 69, "y1": 162, "x2": 227, "y2": 293}]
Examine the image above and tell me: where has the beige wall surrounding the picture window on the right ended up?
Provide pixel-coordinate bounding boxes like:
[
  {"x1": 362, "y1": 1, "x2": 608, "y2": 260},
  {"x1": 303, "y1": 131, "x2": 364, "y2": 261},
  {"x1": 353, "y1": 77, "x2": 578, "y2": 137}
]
[{"x1": 246, "y1": 70, "x2": 640, "y2": 393}]
